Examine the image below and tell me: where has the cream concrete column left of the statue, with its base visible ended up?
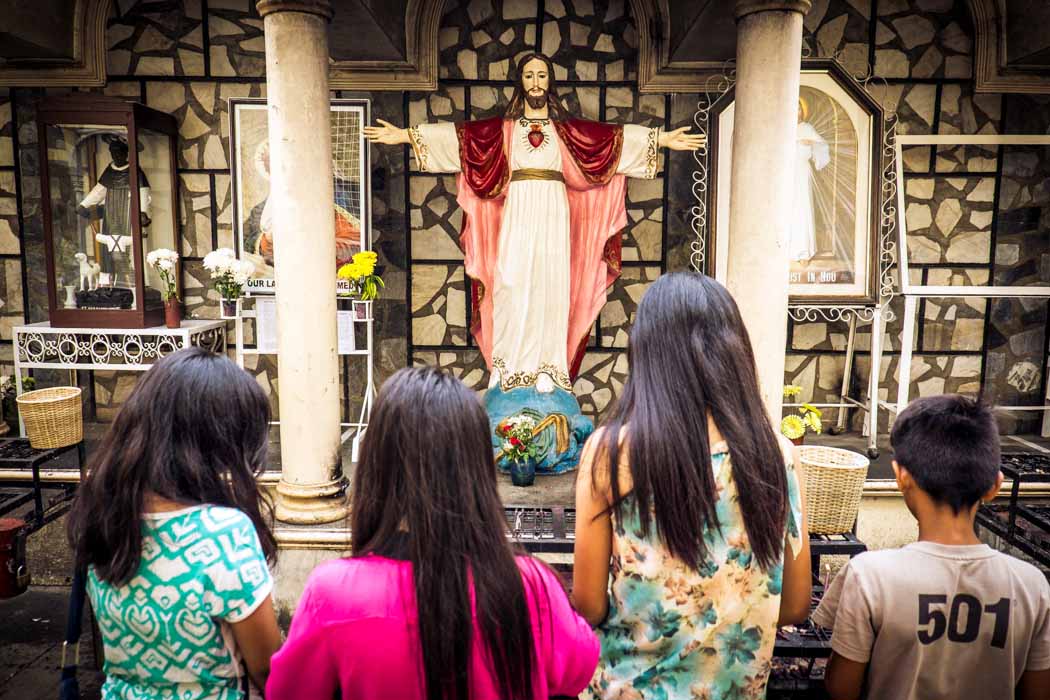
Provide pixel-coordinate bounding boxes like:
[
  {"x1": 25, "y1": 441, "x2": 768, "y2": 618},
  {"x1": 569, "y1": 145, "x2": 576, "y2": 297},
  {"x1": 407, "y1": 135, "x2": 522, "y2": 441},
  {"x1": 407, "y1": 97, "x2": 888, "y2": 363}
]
[{"x1": 256, "y1": 0, "x2": 347, "y2": 524}]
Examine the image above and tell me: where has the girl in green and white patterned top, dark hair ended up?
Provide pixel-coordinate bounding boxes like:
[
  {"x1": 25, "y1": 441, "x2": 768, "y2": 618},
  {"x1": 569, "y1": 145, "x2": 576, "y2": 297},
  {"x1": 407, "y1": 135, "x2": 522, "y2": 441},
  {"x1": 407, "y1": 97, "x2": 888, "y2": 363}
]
[{"x1": 68, "y1": 348, "x2": 280, "y2": 700}]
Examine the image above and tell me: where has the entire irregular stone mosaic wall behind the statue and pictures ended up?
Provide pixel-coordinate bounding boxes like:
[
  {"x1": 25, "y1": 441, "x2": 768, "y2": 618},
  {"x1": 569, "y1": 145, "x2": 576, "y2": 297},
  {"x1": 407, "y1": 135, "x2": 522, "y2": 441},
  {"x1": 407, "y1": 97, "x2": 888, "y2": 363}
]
[{"x1": 0, "y1": 0, "x2": 1050, "y2": 438}]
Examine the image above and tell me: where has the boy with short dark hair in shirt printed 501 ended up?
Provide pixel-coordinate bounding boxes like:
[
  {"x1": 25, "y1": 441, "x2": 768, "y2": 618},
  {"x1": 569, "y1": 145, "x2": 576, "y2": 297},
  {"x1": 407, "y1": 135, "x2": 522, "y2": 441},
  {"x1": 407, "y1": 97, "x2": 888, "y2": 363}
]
[{"x1": 813, "y1": 396, "x2": 1050, "y2": 700}]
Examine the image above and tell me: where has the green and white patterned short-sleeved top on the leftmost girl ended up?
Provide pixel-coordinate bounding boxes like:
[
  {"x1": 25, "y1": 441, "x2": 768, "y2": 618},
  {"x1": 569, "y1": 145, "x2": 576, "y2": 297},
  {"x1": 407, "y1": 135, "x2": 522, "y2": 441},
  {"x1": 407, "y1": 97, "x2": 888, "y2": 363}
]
[{"x1": 87, "y1": 506, "x2": 273, "y2": 700}]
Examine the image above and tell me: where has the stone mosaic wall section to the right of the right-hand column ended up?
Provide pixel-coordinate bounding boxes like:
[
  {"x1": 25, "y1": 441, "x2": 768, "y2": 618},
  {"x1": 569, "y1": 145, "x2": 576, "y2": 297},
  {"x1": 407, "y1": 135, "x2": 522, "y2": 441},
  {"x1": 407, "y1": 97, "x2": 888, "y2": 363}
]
[{"x1": 785, "y1": 0, "x2": 1050, "y2": 432}]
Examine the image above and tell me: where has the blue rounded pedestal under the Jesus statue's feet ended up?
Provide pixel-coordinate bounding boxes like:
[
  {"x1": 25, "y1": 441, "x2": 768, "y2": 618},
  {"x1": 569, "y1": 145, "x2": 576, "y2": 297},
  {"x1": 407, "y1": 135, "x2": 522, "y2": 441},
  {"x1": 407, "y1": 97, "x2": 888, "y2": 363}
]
[{"x1": 485, "y1": 386, "x2": 594, "y2": 474}]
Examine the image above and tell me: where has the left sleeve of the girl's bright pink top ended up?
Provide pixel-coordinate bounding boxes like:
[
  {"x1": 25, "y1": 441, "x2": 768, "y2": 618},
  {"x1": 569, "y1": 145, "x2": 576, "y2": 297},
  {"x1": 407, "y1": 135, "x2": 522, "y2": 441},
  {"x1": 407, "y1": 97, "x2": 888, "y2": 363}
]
[{"x1": 266, "y1": 575, "x2": 339, "y2": 700}]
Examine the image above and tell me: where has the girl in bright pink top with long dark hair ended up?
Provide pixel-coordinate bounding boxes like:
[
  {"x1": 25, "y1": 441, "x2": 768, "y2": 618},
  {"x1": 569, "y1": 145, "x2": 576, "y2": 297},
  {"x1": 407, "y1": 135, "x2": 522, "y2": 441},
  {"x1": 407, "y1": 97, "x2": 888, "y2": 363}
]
[{"x1": 266, "y1": 367, "x2": 599, "y2": 700}]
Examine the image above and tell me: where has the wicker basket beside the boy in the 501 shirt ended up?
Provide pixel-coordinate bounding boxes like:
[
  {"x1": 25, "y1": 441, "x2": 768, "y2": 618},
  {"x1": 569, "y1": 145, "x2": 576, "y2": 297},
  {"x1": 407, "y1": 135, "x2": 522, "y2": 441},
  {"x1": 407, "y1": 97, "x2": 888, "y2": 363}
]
[{"x1": 799, "y1": 445, "x2": 869, "y2": 534}]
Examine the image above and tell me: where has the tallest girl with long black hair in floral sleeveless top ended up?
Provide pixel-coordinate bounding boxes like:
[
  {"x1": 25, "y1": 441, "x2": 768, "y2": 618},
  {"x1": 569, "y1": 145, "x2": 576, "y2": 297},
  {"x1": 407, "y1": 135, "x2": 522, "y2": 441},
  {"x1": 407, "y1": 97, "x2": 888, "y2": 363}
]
[{"x1": 573, "y1": 273, "x2": 812, "y2": 700}]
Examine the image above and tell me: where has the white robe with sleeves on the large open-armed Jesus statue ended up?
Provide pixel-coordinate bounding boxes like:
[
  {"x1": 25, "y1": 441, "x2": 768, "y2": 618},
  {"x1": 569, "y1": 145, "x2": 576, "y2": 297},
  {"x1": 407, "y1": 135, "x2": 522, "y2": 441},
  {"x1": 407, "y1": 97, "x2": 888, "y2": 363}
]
[{"x1": 416, "y1": 120, "x2": 658, "y2": 391}]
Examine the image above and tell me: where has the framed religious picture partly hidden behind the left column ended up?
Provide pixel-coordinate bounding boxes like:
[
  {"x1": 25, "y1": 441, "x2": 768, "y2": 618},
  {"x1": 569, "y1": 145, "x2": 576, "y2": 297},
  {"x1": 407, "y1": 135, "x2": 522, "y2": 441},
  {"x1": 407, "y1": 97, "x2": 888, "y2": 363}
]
[{"x1": 230, "y1": 98, "x2": 372, "y2": 294}]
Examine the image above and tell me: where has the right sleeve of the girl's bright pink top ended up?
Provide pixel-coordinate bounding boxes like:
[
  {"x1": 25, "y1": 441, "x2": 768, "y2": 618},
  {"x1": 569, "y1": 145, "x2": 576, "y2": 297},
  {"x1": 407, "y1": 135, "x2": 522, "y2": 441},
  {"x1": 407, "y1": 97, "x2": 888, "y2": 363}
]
[{"x1": 523, "y1": 560, "x2": 601, "y2": 696}]
